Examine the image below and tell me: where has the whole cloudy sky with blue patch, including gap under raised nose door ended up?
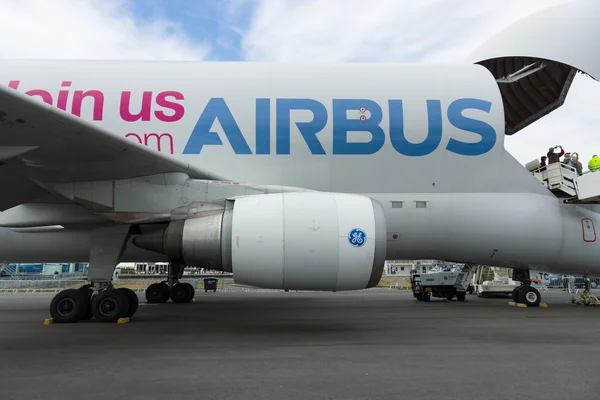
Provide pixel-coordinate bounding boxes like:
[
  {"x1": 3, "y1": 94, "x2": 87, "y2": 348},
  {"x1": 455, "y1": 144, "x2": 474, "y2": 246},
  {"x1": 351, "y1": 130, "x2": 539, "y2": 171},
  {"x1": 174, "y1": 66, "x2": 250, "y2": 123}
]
[{"x1": 0, "y1": 0, "x2": 600, "y2": 163}]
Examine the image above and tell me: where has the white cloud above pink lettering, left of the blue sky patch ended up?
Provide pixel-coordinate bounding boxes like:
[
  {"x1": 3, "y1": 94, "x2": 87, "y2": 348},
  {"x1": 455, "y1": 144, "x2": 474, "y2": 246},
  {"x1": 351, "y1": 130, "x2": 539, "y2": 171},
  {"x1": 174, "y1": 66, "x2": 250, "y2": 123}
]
[{"x1": 0, "y1": 0, "x2": 209, "y2": 60}]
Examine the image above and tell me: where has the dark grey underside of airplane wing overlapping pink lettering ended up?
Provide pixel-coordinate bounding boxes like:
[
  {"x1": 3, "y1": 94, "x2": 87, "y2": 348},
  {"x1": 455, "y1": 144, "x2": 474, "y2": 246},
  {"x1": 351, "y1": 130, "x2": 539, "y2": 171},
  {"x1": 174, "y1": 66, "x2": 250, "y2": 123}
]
[{"x1": 0, "y1": 86, "x2": 218, "y2": 211}]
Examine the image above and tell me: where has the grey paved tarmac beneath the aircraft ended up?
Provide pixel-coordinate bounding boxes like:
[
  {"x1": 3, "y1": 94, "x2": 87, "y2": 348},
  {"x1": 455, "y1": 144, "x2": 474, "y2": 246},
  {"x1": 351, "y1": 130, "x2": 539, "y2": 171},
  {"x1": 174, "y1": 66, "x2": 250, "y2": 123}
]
[{"x1": 0, "y1": 289, "x2": 600, "y2": 400}]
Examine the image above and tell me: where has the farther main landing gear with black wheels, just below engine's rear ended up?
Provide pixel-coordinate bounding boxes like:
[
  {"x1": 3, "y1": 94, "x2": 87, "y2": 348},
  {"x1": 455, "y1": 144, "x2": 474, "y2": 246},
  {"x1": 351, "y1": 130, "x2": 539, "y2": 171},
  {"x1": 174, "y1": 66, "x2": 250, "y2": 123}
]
[{"x1": 146, "y1": 262, "x2": 196, "y2": 303}]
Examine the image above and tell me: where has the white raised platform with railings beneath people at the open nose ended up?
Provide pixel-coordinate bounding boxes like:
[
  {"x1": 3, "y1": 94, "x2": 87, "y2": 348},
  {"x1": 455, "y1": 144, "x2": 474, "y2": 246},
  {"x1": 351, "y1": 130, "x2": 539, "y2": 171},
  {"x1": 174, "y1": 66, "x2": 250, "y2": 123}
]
[{"x1": 525, "y1": 160, "x2": 600, "y2": 204}]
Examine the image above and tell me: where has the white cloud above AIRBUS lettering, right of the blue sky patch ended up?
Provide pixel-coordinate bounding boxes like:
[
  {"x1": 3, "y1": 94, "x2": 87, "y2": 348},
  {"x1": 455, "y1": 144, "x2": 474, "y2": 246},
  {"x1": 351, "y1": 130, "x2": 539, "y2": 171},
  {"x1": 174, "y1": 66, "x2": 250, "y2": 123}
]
[{"x1": 243, "y1": 0, "x2": 569, "y2": 61}]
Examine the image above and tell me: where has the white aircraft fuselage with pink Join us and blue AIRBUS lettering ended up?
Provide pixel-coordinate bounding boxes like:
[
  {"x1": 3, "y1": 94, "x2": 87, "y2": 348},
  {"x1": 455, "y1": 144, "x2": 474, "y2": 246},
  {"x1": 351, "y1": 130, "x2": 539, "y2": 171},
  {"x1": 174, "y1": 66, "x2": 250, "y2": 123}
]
[{"x1": 0, "y1": 61, "x2": 600, "y2": 275}]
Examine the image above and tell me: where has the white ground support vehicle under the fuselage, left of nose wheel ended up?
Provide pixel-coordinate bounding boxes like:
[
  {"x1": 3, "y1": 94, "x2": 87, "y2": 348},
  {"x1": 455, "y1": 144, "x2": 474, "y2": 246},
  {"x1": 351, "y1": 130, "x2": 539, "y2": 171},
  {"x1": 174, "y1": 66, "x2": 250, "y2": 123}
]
[{"x1": 410, "y1": 264, "x2": 475, "y2": 301}]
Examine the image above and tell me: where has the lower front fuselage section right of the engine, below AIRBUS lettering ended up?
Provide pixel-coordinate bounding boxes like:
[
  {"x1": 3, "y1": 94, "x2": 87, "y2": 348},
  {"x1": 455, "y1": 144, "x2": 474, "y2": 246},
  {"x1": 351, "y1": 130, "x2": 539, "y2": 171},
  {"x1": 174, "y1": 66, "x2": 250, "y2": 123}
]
[{"x1": 374, "y1": 193, "x2": 600, "y2": 275}]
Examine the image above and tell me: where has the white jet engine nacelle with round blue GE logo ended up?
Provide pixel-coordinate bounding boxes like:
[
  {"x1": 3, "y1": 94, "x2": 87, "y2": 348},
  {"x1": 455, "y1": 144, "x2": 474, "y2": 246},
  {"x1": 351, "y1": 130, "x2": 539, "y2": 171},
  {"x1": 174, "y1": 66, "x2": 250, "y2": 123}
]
[{"x1": 134, "y1": 192, "x2": 387, "y2": 290}]
